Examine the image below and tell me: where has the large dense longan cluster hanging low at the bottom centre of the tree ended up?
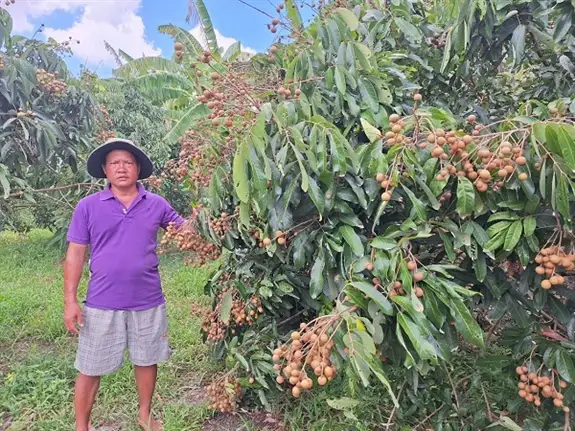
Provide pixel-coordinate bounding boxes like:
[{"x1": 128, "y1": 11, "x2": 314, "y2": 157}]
[{"x1": 273, "y1": 321, "x2": 336, "y2": 398}]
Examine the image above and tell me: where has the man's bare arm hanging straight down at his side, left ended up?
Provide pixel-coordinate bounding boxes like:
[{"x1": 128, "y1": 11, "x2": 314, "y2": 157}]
[{"x1": 64, "y1": 242, "x2": 88, "y2": 334}]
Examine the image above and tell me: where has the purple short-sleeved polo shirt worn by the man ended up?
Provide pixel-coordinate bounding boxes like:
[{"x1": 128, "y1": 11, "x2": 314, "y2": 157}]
[{"x1": 67, "y1": 184, "x2": 184, "y2": 310}]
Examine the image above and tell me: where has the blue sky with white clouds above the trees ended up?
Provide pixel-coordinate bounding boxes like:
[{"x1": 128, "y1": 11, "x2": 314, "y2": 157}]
[{"x1": 0, "y1": 0, "x2": 316, "y2": 76}]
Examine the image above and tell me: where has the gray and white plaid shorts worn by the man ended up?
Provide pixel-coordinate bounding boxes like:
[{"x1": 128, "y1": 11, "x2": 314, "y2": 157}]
[{"x1": 74, "y1": 304, "x2": 172, "y2": 376}]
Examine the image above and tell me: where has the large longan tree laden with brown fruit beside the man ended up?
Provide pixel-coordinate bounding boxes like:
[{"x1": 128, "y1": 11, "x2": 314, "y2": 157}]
[{"x1": 156, "y1": 1, "x2": 575, "y2": 427}]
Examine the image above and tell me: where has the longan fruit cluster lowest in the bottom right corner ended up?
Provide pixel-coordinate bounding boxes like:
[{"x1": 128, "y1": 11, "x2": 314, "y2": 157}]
[{"x1": 515, "y1": 366, "x2": 569, "y2": 413}]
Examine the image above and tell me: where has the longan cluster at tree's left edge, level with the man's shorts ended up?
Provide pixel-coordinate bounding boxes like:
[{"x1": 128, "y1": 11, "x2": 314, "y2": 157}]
[{"x1": 202, "y1": 288, "x2": 264, "y2": 341}]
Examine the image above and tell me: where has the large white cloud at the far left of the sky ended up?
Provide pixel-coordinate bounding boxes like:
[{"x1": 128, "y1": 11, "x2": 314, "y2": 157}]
[{"x1": 2, "y1": 0, "x2": 161, "y2": 66}]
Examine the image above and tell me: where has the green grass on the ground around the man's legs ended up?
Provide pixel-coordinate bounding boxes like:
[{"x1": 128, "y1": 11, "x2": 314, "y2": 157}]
[{"x1": 0, "y1": 231, "x2": 217, "y2": 431}]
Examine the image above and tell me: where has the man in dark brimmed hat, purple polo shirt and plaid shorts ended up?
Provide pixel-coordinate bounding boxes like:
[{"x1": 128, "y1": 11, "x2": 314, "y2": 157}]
[{"x1": 64, "y1": 139, "x2": 184, "y2": 431}]
